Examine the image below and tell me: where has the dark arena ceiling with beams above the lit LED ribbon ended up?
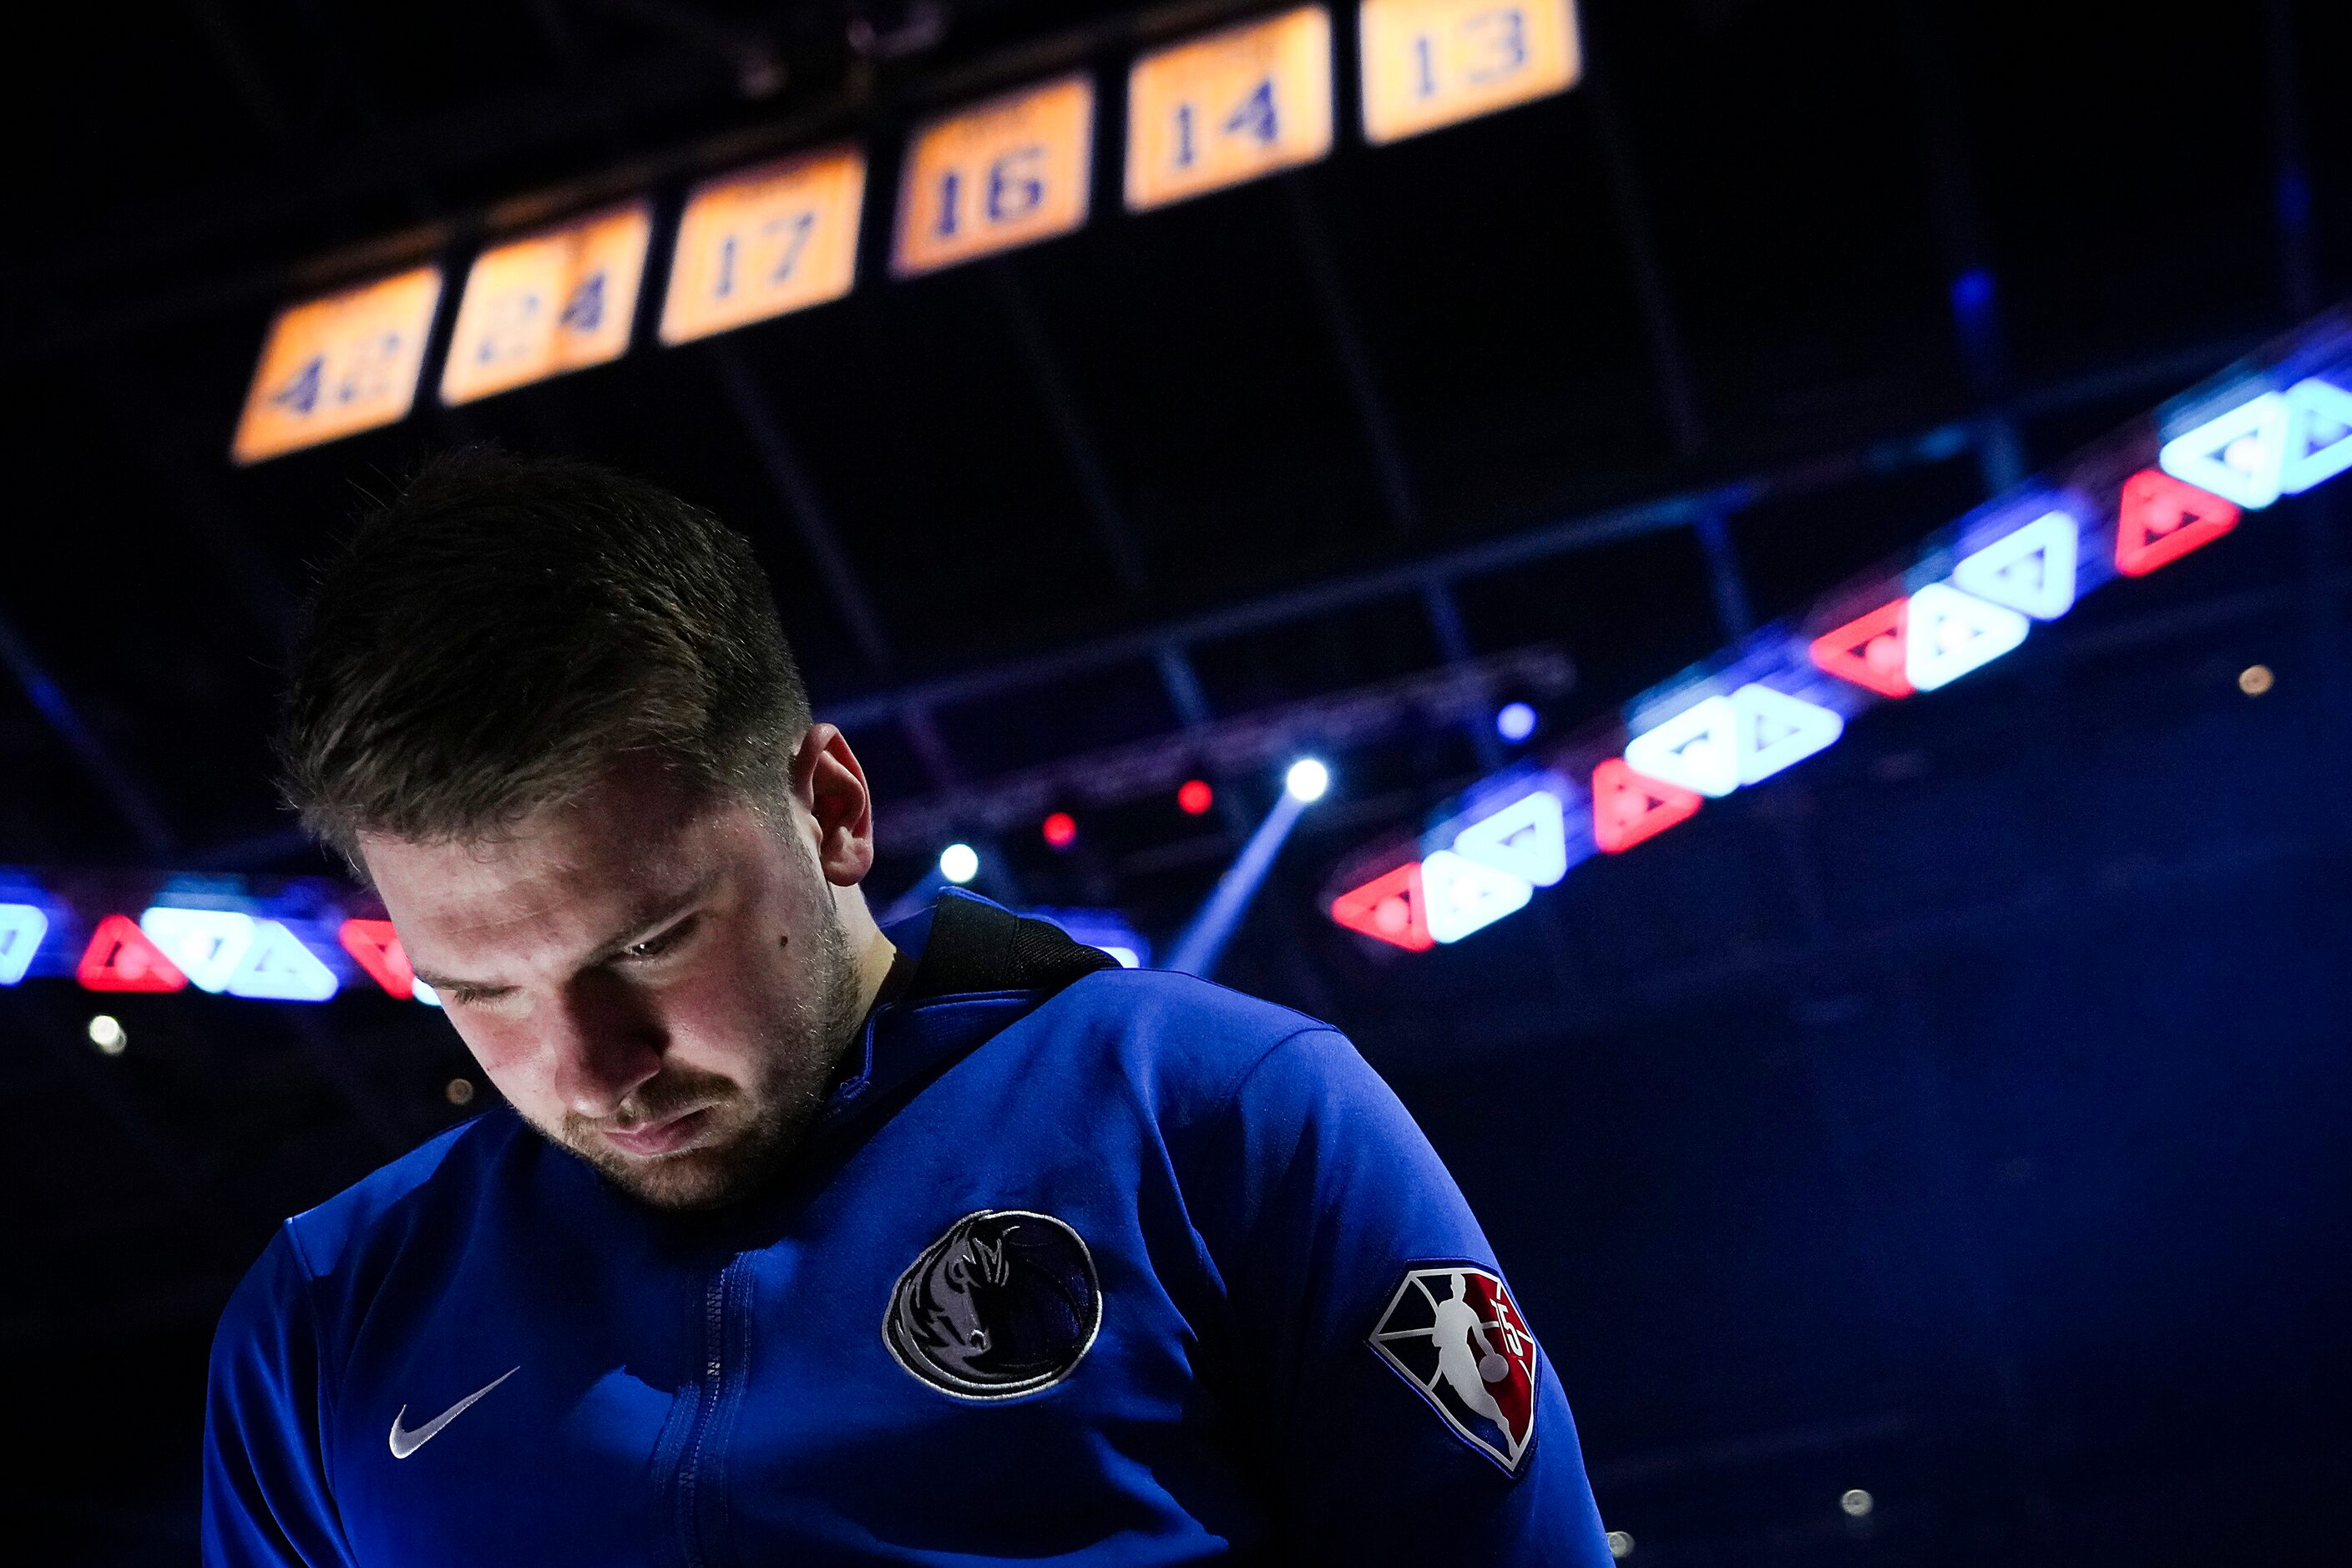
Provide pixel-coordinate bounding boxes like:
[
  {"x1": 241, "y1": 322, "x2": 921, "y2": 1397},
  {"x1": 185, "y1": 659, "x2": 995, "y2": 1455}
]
[{"x1": 13, "y1": 0, "x2": 2347, "y2": 910}]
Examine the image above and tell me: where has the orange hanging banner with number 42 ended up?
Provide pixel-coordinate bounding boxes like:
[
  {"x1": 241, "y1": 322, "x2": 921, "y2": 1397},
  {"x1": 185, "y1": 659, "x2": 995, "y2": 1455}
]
[{"x1": 228, "y1": 266, "x2": 443, "y2": 463}]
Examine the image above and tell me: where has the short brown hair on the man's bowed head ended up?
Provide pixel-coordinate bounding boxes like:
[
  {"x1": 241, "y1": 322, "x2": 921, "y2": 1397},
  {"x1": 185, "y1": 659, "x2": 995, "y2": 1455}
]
[{"x1": 277, "y1": 449, "x2": 809, "y2": 865}]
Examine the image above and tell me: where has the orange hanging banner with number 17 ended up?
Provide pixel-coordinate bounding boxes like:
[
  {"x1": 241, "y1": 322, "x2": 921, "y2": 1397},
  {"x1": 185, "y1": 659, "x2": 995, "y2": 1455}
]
[{"x1": 661, "y1": 148, "x2": 866, "y2": 343}]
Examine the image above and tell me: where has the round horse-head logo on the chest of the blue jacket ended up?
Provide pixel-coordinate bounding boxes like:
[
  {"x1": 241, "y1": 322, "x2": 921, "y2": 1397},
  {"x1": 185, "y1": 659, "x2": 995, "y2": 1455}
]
[{"x1": 882, "y1": 1208, "x2": 1103, "y2": 1399}]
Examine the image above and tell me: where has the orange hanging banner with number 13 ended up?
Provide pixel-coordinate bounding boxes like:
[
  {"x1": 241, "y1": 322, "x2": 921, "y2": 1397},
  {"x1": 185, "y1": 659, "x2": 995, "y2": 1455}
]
[{"x1": 1357, "y1": 0, "x2": 1583, "y2": 144}]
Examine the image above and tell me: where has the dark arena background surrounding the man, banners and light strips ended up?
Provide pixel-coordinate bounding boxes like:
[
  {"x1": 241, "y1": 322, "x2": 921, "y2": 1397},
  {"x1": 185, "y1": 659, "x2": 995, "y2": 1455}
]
[{"x1": 0, "y1": 0, "x2": 2352, "y2": 1568}]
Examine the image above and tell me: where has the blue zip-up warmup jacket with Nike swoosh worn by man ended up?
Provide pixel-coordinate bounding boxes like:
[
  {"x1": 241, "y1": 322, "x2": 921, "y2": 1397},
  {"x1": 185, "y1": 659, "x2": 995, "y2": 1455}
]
[{"x1": 205, "y1": 893, "x2": 1609, "y2": 1568}]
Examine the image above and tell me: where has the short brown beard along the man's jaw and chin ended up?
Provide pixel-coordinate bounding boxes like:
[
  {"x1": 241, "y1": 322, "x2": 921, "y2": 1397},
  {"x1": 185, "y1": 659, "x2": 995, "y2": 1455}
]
[{"x1": 541, "y1": 893, "x2": 861, "y2": 1208}]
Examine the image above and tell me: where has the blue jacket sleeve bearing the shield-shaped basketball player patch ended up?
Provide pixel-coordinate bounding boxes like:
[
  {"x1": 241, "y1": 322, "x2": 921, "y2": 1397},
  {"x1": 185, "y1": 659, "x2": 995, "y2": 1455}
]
[{"x1": 1183, "y1": 1029, "x2": 1611, "y2": 1568}]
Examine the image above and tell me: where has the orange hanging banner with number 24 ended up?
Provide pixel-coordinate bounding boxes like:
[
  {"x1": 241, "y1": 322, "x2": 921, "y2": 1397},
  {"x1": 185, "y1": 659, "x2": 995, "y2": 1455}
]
[{"x1": 443, "y1": 202, "x2": 654, "y2": 402}]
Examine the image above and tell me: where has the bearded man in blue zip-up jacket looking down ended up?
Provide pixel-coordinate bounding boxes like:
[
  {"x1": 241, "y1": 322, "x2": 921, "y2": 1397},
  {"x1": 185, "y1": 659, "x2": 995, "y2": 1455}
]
[{"x1": 205, "y1": 453, "x2": 1609, "y2": 1568}]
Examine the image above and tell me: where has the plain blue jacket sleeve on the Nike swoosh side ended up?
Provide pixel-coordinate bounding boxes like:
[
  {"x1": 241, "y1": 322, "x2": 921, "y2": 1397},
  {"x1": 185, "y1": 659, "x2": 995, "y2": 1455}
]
[{"x1": 205, "y1": 1230, "x2": 353, "y2": 1568}]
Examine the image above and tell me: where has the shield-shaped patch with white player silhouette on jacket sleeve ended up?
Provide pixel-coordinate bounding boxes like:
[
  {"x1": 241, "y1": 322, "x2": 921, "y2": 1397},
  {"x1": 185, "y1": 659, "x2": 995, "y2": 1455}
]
[{"x1": 1367, "y1": 1262, "x2": 1536, "y2": 1476}]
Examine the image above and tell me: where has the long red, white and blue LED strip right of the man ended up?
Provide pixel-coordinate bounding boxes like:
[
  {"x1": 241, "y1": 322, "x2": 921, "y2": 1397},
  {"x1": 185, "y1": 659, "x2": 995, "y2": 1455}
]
[{"x1": 1324, "y1": 312, "x2": 2352, "y2": 952}]
